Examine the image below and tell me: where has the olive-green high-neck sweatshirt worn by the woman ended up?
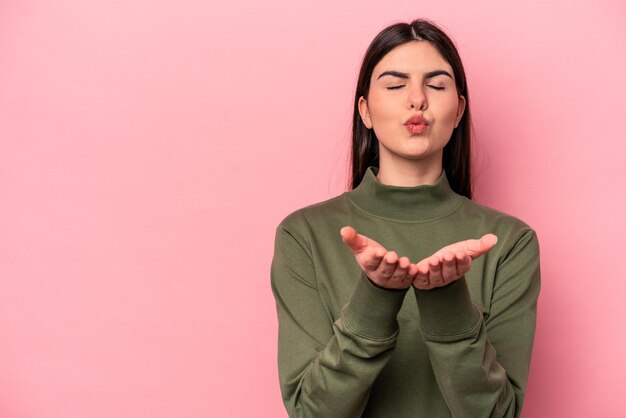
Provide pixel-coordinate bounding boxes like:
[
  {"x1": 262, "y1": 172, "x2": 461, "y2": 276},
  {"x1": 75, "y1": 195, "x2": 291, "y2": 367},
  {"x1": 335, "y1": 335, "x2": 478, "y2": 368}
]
[{"x1": 271, "y1": 166, "x2": 540, "y2": 418}]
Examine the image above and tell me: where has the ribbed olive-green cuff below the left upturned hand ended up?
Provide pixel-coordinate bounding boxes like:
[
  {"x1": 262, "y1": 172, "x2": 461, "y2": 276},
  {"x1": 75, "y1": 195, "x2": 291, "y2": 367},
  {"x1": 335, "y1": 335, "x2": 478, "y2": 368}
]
[{"x1": 343, "y1": 271, "x2": 408, "y2": 340}]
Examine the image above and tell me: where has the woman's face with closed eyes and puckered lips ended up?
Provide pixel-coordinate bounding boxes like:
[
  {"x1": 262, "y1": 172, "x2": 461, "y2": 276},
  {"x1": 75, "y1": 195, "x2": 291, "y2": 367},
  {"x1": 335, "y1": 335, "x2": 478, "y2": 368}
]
[{"x1": 358, "y1": 41, "x2": 465, "y2": 163}]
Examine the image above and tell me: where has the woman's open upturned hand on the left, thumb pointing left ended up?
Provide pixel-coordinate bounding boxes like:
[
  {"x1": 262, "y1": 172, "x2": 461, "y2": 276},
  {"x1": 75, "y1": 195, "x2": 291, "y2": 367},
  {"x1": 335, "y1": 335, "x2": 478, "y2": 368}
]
[{"x1": 339, "y1": 226, "x2": 417, "y2": 289}]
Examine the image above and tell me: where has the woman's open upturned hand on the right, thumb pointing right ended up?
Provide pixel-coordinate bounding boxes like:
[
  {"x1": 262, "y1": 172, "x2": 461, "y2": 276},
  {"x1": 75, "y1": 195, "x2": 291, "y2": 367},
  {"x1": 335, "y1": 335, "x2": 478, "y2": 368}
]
[{"x1": 413, "y1": 234, "x2": 498, "y2": 290}]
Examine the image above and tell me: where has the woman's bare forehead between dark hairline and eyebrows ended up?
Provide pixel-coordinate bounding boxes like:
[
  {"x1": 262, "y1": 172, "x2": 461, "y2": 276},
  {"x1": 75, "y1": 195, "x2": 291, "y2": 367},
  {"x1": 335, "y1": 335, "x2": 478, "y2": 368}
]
[{"x1": 372, "y1": 41, "x2": 452, "y2": 79}]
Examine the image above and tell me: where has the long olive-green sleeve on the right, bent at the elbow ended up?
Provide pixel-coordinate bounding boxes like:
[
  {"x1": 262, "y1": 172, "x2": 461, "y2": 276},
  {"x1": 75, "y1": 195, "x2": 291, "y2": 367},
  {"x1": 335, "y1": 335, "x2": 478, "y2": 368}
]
[{"x1": 415, "y1": 229, "x2": 541, "y2": 418}]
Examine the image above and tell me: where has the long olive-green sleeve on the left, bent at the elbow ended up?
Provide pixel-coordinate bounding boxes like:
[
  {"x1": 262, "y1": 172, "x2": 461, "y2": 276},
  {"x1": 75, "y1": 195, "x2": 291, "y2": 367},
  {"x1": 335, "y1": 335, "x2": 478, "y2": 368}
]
[{"x1": 271, "y1": 224, "x2": 406, "y2": 418}]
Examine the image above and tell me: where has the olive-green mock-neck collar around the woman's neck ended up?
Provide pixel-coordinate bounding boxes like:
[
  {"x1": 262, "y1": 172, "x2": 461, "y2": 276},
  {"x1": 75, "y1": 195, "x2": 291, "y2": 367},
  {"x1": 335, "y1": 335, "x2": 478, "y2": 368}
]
[{"x1": 347, "y1": 166, "x2": 464, "y2": 222}]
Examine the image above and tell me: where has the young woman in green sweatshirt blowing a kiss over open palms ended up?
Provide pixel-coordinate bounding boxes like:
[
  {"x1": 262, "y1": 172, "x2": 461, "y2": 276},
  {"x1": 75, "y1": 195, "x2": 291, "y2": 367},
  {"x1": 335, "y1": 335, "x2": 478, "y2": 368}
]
[{"x1": 271, "y1": 20, "x2": 540, "y2": 418}]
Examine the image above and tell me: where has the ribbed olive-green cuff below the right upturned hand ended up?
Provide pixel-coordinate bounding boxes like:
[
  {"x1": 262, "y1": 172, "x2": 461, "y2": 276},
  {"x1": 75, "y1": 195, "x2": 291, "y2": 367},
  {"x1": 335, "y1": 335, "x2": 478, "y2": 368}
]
[{"x1": 414, "y1": 276, "x2": 482, "y2": 337}]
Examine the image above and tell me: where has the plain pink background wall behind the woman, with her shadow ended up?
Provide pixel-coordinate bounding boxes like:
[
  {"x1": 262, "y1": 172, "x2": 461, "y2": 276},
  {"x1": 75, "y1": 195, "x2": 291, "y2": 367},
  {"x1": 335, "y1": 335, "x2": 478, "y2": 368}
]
[{"x1": 0, "y1": 0, "x2": 626, "y2": 418}]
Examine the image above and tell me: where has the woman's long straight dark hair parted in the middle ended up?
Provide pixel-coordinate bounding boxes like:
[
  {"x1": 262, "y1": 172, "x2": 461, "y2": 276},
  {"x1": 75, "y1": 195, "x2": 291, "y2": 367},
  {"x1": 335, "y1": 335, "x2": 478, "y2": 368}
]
[{"x1": 350, "y1": 19, "x2": 472, "y2": 199}]
